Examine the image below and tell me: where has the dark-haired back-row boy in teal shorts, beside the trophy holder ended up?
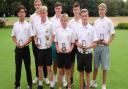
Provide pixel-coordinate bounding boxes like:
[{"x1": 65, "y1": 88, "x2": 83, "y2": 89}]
[{"x1": 50, "y1": 2, "x2": 67, "y2": 87}]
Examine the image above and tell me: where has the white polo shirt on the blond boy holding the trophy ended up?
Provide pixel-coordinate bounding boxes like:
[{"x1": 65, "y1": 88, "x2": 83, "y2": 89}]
[{"x1": 34, "y1": 20, "x2": 52, "y2": 49}]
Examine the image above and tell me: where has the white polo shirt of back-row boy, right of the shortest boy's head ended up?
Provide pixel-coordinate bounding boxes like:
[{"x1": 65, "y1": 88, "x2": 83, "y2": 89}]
[{"x1": 69, "y1": 18, "x2": 82, "y2": 40}]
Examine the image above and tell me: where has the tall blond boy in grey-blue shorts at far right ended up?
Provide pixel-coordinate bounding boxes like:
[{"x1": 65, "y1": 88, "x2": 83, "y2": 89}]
[{"x1": 91, "y1": 3, "x2": 115, "y2": 89}]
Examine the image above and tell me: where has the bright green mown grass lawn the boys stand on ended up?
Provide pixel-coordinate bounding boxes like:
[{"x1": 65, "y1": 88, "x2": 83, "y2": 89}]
[{"x1": 0, "y1": 28, "x2": 128, "y2": 89}]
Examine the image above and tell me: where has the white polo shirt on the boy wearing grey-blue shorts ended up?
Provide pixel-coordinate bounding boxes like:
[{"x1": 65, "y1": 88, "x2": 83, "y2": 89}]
[{"x1": 94, "y1": 17, "x2": 115, "y2": 41}]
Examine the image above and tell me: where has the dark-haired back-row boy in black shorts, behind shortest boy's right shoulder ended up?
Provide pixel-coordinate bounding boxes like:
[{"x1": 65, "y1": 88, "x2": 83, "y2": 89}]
[{"x1": 69, "y1": 3, "x2": 82, "y2": 86}]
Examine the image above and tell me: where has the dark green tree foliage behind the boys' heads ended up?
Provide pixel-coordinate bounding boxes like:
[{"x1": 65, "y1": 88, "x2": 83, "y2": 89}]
[{"x1": 0, "y1": 0, "x2": 128, "y2": 16}]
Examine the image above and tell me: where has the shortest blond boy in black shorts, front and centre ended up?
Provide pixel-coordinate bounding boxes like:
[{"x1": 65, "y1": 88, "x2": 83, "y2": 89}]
[{"x1": 55, "y1": 14, "x2": 75, "y2": 89}]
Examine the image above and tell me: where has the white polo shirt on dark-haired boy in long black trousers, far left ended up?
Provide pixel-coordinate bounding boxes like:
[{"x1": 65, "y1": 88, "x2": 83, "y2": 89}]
[{"x1": 11, "y1": 20, "x2": 34, "y2": 44}]
